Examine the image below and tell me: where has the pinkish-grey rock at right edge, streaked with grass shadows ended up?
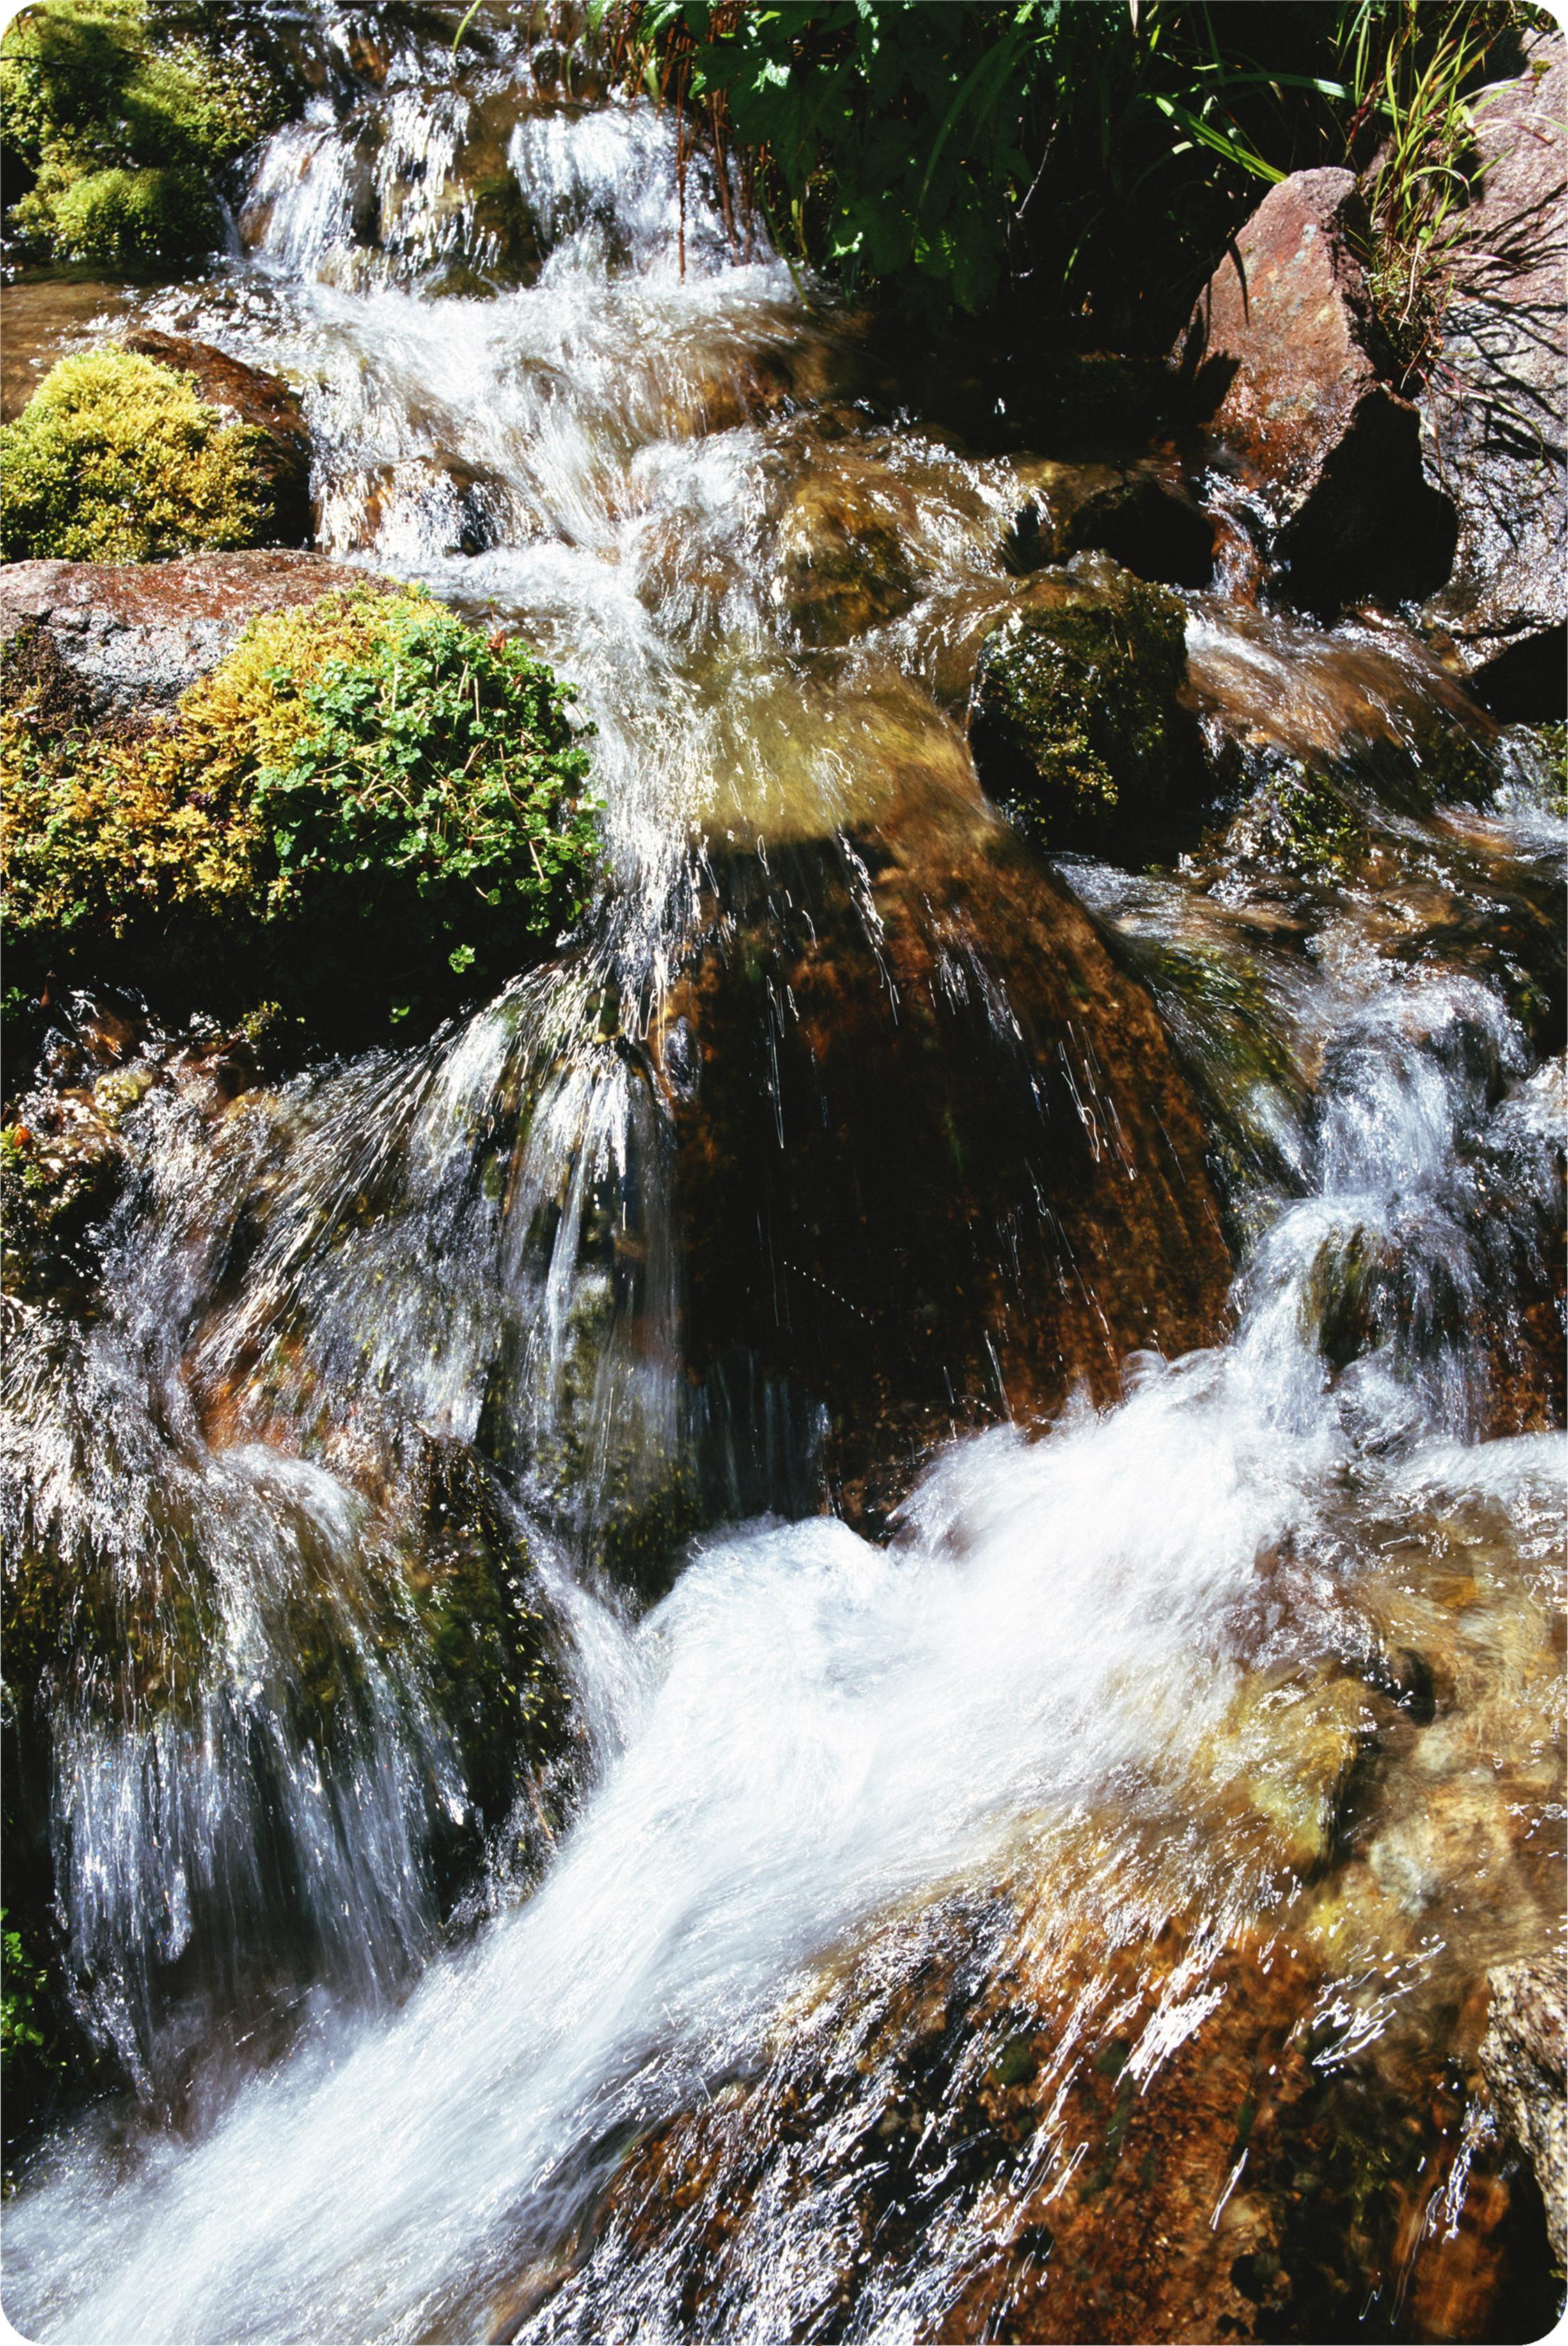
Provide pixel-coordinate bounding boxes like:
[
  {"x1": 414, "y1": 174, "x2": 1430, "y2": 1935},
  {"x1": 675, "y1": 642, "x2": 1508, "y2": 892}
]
[{"x1": 1420, "y1": 33, "x2": 1568, "y2": 718}]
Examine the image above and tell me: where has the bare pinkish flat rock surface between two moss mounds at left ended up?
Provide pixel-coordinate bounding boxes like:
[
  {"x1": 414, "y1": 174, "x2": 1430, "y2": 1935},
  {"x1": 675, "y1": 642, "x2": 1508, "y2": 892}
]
[{"x1": 0, "y1": 552, "x2": 399, "y2": 718}]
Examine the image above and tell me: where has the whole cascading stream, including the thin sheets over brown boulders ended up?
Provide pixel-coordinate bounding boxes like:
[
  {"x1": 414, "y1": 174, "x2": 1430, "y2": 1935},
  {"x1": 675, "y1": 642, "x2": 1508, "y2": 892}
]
[{"x1": 5, "y1": 4, "x2": 1566, "y2": 2346}]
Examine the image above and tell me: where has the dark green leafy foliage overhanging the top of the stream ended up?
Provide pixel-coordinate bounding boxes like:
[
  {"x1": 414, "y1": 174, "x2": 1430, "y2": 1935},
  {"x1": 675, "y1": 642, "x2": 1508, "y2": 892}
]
[{"x1": 608, "y1": 0, "x2": 1523, "y2": 347}]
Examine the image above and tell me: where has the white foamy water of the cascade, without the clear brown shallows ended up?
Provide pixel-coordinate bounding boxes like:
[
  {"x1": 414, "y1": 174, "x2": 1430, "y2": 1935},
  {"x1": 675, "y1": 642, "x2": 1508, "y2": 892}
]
[{"x1": 5, "y1": 9, "x2": 1563, "y2": 2346}]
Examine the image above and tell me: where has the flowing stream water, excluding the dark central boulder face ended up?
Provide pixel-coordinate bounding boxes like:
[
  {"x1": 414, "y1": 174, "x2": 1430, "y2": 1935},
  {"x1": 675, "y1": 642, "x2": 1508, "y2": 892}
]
[{"x1": 5, "y1": 19, "x2": 1563, "y2": 2346}]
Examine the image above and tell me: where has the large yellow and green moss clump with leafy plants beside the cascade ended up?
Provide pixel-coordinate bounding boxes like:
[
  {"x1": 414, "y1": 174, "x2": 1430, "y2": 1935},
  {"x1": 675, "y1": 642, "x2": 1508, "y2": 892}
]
[{"x1": 0, "y1": 586, "x2": 599, "y2": 1039}]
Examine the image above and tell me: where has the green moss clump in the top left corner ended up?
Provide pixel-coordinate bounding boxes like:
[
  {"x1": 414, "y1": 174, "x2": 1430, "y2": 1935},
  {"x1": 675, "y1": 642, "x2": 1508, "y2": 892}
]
[{"x1": 0, "y1": 0, "x2": 277, "y2": 267}]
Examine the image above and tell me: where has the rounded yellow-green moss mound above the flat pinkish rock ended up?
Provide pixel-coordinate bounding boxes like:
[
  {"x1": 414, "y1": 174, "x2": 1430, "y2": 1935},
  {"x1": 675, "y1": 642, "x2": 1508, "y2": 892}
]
[{"x1": 0, "y1": 347, "x2": 270, "y2": 563}]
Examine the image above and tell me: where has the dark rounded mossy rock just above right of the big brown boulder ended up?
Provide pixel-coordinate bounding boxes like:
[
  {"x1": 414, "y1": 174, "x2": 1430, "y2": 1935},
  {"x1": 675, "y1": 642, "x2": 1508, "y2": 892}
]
[{"x1": 969, "y1": 554, "x2": 1202, "y2": 861}]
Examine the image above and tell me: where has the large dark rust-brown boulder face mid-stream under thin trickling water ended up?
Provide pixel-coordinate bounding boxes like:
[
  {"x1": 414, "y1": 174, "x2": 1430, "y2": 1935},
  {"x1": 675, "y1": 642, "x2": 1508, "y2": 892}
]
[{"x1": 657, "y1": 760, "x2": 1230, "y2": 1522}]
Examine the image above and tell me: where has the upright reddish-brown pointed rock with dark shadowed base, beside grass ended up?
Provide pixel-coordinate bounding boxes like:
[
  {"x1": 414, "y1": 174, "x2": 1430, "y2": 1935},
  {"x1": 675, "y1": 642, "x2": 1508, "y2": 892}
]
[{"x1": 1181, "y1": 171, "x2": 1455, "y2": 612}]
